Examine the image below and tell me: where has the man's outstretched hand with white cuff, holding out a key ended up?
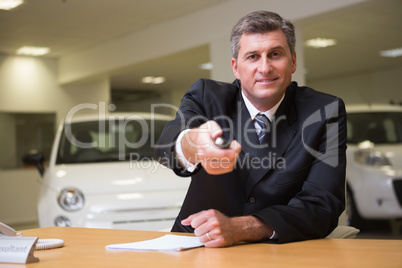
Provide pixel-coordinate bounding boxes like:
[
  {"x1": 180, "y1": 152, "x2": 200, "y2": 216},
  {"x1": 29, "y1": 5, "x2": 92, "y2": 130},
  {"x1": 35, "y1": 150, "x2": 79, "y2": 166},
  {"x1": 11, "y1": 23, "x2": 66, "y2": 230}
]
[{"x1": 181, "y1": 121, "x2": 241, "y2": 175}]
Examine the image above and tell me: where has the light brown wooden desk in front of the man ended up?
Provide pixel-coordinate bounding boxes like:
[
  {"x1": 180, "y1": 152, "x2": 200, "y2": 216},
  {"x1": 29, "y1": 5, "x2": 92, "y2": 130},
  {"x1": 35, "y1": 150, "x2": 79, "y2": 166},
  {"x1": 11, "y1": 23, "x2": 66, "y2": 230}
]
[{"x1": 7, "y1": 227, "x2": 402, "y2": 268}]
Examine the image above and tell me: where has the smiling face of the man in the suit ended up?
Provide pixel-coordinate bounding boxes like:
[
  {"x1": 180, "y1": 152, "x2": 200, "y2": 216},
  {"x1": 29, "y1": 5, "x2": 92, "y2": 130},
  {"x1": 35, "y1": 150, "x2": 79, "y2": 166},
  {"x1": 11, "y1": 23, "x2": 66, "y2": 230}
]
[{"x1": 232, "y1": 30, "x2": 296, "y2": 111}]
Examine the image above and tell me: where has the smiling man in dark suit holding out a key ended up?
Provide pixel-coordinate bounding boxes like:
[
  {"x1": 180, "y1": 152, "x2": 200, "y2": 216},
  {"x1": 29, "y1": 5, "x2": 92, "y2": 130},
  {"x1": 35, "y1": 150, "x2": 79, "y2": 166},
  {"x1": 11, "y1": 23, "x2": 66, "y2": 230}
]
[{"x1": 155, "y1": 11, "x2": 346, "y2": 247}]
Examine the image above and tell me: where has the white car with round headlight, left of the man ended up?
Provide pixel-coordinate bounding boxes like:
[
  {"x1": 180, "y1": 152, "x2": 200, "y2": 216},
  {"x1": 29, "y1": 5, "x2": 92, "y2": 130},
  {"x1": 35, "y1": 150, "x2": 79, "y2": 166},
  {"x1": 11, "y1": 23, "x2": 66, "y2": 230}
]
[{"x1": 25, "y1": 113, "x2": 190, "y2": 231}]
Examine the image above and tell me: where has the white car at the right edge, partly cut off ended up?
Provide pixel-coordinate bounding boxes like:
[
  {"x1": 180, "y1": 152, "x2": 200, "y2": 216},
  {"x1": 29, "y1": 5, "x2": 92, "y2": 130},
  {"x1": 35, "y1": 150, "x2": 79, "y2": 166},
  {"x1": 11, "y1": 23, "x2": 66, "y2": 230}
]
[{"x1": 346, "y1": 105, "x2": 402, "y2": 229}]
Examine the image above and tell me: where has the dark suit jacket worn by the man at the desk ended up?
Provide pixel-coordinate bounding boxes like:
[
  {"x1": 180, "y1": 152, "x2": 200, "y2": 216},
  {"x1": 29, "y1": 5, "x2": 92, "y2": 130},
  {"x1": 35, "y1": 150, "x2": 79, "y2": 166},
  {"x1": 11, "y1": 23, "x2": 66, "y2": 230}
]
[{"x1": 155, "y1": 79, "x2": 346, "y2": 243}]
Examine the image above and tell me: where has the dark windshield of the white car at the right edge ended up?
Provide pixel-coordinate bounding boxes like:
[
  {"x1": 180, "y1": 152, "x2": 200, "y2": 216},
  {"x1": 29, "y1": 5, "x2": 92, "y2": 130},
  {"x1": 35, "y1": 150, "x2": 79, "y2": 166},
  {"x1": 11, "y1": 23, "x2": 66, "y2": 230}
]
[{"x1": 347, "y1": 112, "x2": 402, "y2": 144}]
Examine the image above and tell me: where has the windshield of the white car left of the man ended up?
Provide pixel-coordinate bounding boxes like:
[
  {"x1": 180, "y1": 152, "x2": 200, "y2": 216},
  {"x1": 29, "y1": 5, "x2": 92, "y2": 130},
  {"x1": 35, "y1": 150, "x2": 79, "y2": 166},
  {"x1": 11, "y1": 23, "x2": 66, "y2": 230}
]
[{"x1": 56, "y1": 117, "x2": 167, "y2": 164}]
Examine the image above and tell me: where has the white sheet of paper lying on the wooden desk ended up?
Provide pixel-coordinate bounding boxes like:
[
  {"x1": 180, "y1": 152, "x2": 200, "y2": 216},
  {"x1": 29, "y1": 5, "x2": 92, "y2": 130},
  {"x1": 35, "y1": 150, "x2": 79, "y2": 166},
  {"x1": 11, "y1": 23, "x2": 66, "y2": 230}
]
[{"x1": 106, "y1": 235, "x2": 204, "y2": 251}]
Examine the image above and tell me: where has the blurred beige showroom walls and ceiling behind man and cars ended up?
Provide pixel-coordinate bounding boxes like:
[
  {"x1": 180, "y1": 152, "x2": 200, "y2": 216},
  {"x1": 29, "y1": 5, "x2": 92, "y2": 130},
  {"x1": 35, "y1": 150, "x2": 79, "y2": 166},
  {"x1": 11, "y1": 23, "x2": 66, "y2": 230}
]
[{"x1": 0, "y1": 0, "x2": 402, "y2": 239}]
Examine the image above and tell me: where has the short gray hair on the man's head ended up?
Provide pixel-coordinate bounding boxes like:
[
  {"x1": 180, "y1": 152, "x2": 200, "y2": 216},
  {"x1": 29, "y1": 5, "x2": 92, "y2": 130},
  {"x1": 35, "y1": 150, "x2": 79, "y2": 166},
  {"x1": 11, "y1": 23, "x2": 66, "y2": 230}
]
[{"x1": 230, "y1": 11, "x2": 296, "y2": 60}]
